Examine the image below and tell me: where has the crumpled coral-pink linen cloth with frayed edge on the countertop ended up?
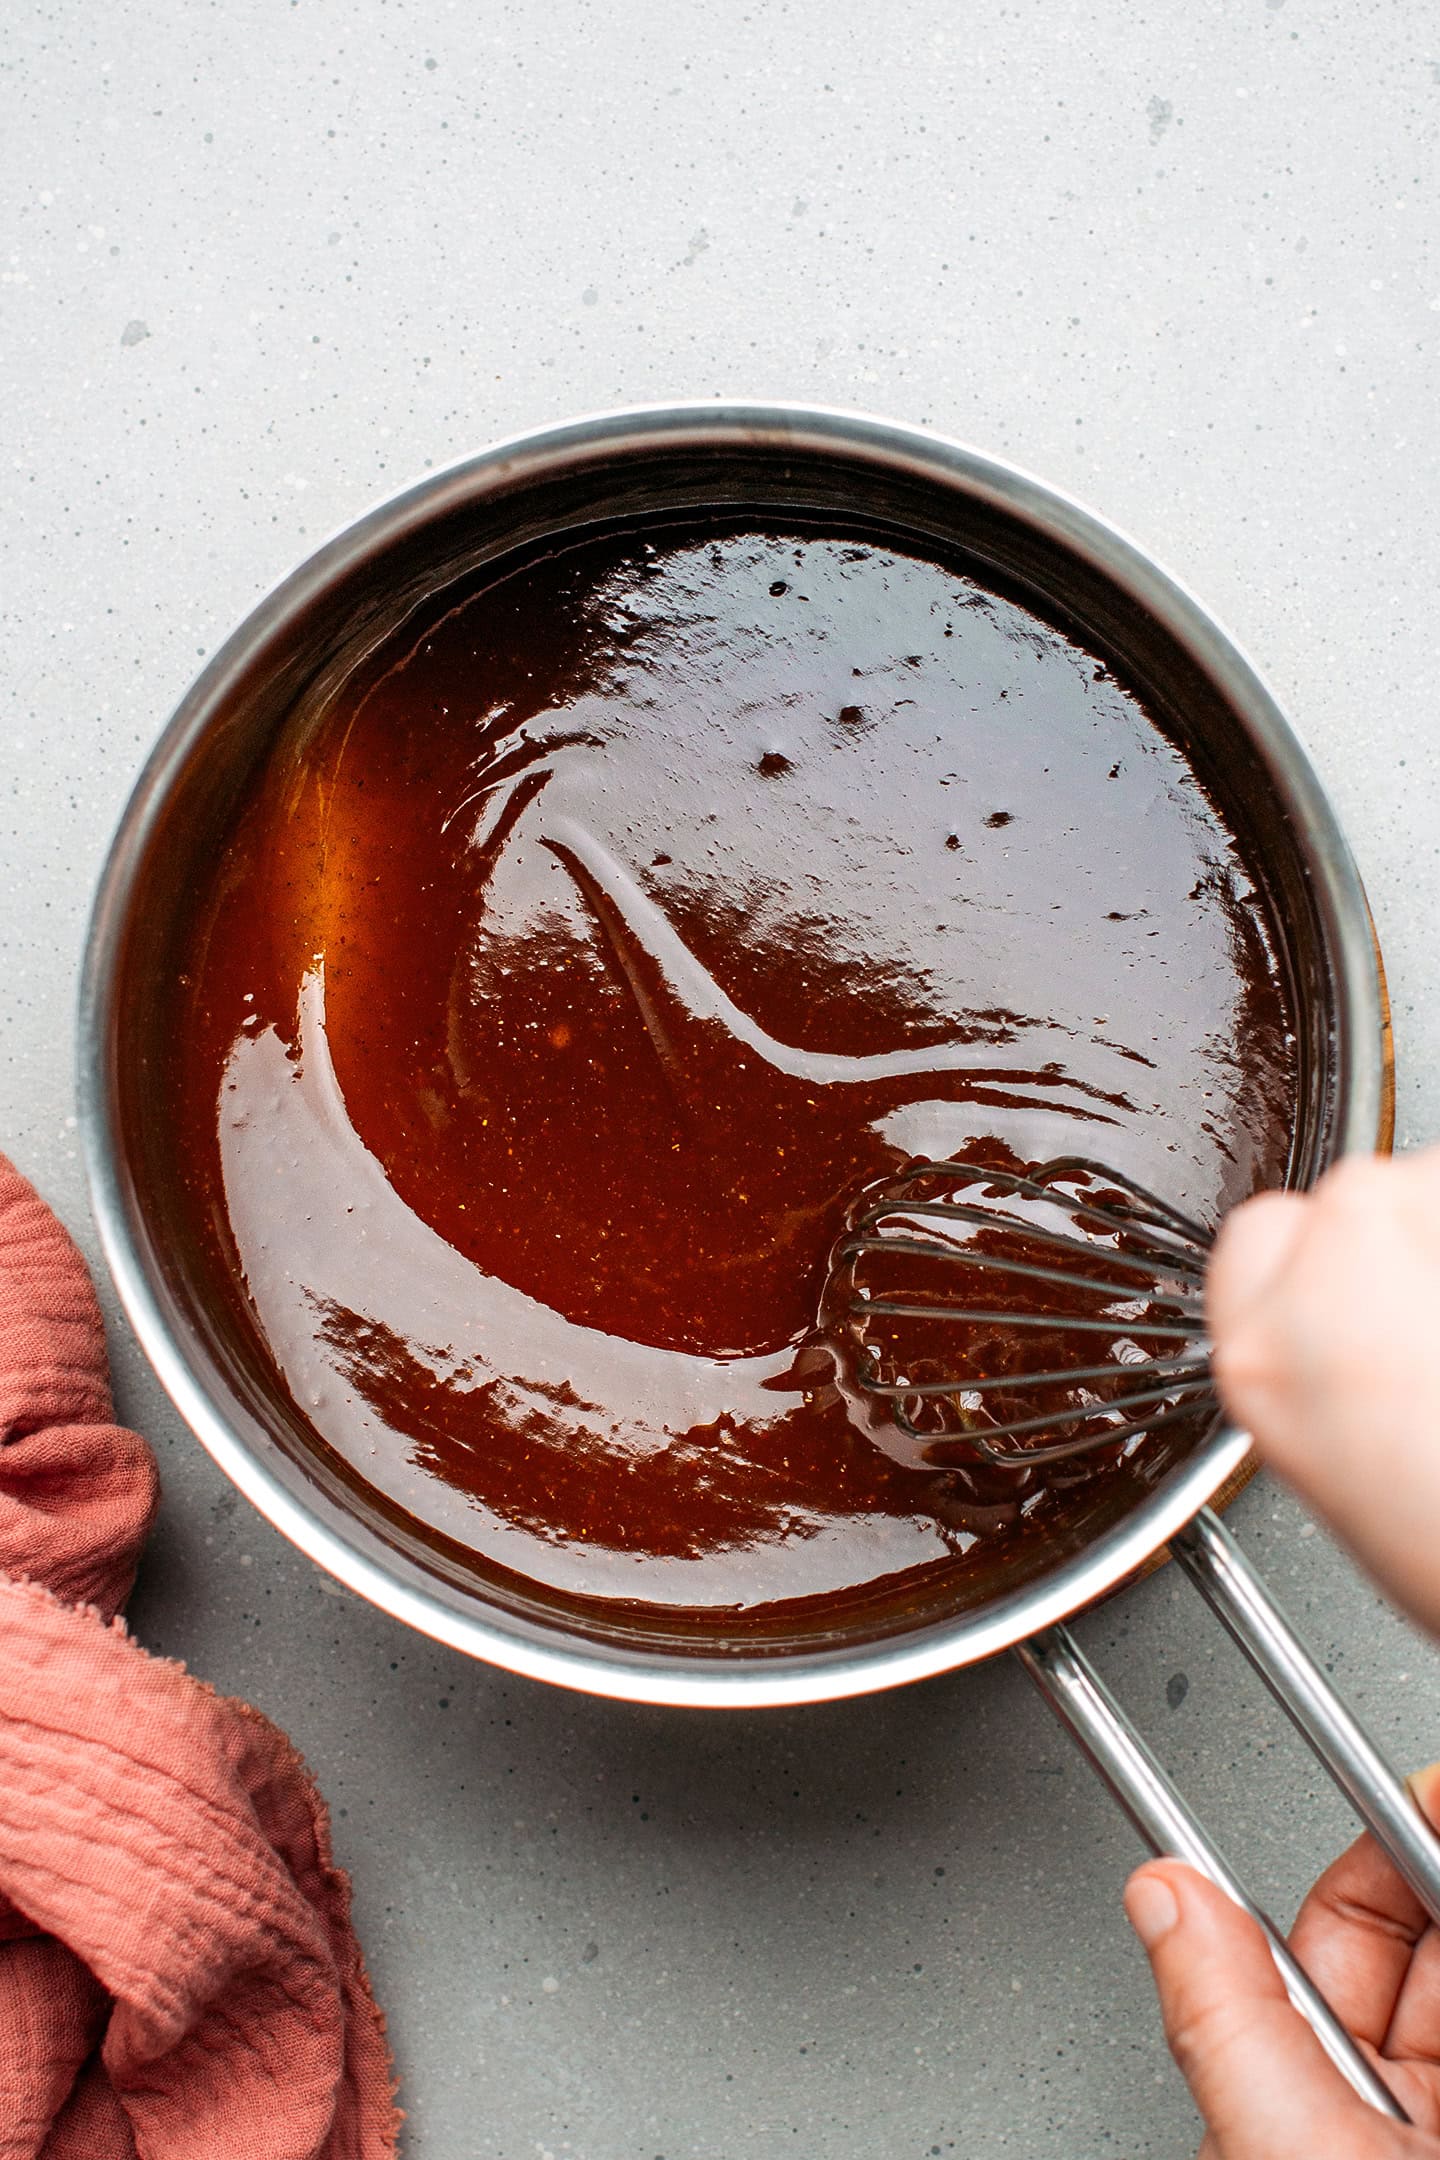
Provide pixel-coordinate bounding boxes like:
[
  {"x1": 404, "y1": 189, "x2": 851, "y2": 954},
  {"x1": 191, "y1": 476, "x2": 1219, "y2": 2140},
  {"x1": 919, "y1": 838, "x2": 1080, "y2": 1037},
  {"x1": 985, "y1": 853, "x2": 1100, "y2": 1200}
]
[{"x1": 0, "y1": 1156, "x2": 399, "y2": 2160}]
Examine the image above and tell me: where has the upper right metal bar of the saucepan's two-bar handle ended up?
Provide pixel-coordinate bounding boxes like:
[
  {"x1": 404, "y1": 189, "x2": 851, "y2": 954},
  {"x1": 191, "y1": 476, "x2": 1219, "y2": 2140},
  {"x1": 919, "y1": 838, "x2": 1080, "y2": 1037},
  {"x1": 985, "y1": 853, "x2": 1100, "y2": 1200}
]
[{"x1": 1170, "y1": 1508, "x2": 1440, "y2": 1927}]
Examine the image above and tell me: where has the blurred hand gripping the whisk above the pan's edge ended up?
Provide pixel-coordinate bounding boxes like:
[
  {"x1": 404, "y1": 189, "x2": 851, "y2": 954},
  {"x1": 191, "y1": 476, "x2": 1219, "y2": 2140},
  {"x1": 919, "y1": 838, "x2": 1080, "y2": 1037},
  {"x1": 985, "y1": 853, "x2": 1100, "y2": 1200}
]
[{"x1": 1209, "y1": 1149, "x2": 1440, "y2": 1632}]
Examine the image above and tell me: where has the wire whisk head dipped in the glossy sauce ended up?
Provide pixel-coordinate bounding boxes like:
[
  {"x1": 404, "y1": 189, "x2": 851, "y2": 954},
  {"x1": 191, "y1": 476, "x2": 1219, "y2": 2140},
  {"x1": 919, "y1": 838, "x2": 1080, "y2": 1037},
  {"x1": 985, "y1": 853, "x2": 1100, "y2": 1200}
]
[{"x1": 825, "y1": 1156, "x2": 1215, "y2": 1469}]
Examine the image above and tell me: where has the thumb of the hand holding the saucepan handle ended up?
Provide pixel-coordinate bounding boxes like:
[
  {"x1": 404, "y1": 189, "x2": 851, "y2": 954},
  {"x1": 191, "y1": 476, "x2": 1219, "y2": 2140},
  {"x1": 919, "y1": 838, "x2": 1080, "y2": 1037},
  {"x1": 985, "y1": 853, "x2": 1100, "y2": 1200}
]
[{"x1": 1125, "y1": 1860, "x2": 1380, "y2": 2160}]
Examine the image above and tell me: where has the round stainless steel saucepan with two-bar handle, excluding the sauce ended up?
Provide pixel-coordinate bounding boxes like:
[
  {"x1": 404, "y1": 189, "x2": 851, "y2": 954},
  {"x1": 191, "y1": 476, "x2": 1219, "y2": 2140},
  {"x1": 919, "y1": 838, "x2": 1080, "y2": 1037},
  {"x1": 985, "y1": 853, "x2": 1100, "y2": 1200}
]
[{"x1": 80, "y1": 404, "x2": 1440, "y2": 2115}]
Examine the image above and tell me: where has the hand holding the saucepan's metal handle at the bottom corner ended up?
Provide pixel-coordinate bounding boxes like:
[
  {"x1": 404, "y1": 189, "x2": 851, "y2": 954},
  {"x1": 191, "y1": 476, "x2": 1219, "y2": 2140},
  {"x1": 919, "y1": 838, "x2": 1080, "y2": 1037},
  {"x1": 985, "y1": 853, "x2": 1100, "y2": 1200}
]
[{"x1": 1125, "y1": 1765, "x2": 1440, "y2": 2160}]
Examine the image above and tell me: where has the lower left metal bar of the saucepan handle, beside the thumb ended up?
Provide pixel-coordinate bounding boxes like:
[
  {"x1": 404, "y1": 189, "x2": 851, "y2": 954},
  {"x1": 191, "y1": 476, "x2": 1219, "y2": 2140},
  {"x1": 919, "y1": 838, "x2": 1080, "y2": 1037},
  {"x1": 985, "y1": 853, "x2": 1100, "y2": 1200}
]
[{"x1": 1015, "y1": 1626, "x2": 1410, "y2": 2123}]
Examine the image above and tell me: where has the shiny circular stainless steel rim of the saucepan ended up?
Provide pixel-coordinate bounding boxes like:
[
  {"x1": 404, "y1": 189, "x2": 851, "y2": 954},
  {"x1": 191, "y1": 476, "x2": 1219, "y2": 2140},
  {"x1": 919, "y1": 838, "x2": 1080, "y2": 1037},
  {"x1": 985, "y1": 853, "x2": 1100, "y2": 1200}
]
[{"x1": 78, "y1": 402, "x2": 1384, "y2": 1709}]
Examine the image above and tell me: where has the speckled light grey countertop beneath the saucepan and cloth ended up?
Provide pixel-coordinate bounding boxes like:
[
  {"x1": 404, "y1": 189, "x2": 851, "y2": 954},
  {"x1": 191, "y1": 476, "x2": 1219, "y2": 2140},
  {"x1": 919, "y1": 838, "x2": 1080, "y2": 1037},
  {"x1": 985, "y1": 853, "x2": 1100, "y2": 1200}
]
[{"x1": 0, "y1": 0, "x2": 1440, "y2": 2160}]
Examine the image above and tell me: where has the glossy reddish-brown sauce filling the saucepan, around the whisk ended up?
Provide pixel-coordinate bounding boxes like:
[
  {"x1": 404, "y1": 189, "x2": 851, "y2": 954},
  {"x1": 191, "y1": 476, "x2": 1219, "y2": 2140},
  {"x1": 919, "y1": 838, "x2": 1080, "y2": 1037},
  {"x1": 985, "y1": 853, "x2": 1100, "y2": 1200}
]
[{"x1": 175, "y1": 518, "x2": 1293, "y2": 1626}]
